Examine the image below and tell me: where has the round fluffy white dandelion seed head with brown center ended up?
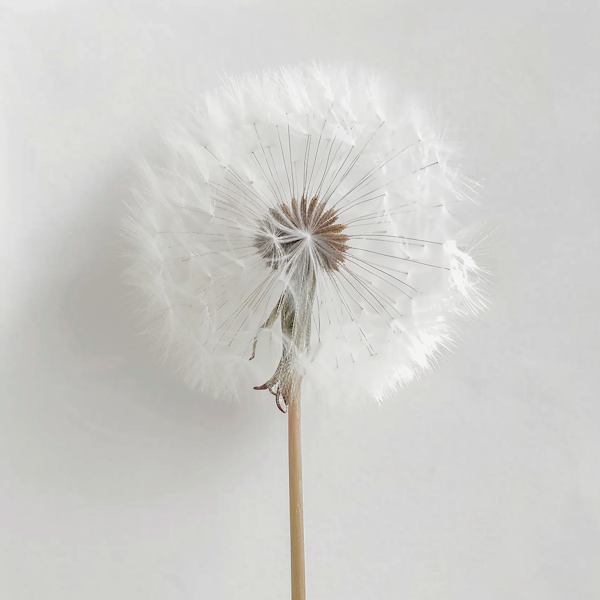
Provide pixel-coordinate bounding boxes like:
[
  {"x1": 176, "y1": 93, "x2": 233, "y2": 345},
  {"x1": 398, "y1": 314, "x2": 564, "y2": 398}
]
[{"x1": 127, "y1": 66, "x2": 484, "y2": 401}]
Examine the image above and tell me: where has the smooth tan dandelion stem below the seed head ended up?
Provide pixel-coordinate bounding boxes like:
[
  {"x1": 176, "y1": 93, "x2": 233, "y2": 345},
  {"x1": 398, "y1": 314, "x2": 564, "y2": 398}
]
[{"x1": 288, "y1": 377, "x2": 306, "y2": 600}]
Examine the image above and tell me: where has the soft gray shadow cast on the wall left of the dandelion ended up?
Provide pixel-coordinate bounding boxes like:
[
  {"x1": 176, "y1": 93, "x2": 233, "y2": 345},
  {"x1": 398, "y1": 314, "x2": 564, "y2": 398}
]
[{"x1": 0, "y1": 154, "x2": 285, "y2": 504}]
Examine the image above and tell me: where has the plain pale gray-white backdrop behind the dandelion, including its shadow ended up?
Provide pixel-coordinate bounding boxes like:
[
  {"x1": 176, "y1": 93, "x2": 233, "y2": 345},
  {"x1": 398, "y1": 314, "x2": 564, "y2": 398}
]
[{"x1": 0, "y1": 0, "x2": 600, "y2": 600}]
